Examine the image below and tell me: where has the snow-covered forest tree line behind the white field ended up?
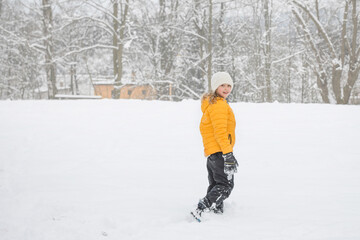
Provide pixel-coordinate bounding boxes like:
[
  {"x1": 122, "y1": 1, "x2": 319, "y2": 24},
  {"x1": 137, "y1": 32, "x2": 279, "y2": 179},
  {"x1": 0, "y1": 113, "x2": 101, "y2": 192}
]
[{"x1": 0, "y1": 0, "x2": 360, "y2": 104}]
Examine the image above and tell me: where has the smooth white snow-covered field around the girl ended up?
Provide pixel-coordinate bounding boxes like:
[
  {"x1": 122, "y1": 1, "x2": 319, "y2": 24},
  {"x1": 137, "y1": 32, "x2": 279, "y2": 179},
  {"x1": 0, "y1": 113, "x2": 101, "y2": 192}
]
[{"x1": 0, "y1": 100, "x2": 360, "y2": 240}]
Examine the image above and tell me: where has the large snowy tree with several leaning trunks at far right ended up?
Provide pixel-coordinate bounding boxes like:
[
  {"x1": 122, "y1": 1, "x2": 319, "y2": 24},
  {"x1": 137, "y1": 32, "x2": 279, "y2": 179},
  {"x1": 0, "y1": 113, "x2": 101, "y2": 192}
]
[{"x1": 291, "y1": 0, "x2": 360, "y2": 104}]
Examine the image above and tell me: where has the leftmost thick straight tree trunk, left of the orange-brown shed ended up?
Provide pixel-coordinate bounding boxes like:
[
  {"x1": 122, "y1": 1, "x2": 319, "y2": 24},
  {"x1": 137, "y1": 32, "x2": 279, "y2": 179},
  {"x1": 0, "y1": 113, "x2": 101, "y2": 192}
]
[{"x1": 42, "y1": 0, "x2": 57, "y2": 99}]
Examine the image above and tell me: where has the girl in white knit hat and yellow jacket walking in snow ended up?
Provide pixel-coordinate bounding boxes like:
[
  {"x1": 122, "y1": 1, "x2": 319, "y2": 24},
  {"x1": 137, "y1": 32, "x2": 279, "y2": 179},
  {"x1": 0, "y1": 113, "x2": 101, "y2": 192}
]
[{"x1": 193, "y1": 72, "x2": 238, "y2": 218}]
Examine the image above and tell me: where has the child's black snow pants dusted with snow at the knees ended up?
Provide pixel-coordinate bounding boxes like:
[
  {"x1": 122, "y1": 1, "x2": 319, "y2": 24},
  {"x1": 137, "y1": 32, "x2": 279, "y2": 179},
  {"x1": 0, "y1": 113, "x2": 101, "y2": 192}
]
[{"x1": 206, "y1": 152, "x2": 234, "y2": 206}]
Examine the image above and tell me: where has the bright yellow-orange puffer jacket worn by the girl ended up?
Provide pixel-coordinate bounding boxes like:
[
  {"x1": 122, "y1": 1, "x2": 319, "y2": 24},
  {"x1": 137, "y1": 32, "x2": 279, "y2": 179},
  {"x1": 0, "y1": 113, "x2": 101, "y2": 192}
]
[{"x1": 200, "y1": 97, "x2": 236, "y2": 156}]
